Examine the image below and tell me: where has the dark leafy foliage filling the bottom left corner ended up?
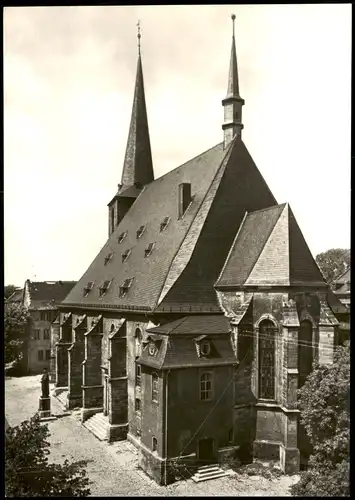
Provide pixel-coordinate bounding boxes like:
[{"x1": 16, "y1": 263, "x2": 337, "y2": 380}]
[{"x1": 5, "y1": 415, "x2": 90, "y2": 497}]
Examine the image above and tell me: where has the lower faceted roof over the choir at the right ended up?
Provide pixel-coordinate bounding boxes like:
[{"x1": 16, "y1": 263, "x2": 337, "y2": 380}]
[{"x1": 216, "y1": 204, "x2": 326, "y2": 288}]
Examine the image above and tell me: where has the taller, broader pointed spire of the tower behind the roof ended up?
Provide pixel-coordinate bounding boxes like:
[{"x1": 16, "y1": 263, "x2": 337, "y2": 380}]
[{"x1": 120, "y1": 21, "x2": 154, "y2": 192}]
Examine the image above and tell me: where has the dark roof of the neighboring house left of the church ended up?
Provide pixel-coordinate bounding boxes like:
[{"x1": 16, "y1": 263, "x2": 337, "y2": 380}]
[{"x1": 26, "y1": 280, "x2": 76, "y2": 309}]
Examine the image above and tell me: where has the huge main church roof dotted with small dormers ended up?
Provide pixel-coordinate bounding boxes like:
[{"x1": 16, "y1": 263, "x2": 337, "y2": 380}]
[{"x1": 63, "y1": 137, "x2": 276, "y2": 312}]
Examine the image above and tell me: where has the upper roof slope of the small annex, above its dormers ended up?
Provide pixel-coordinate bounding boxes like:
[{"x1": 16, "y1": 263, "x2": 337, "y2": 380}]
[{"x1": 149, "y1": 314, "x2": 231, "y2": 335}]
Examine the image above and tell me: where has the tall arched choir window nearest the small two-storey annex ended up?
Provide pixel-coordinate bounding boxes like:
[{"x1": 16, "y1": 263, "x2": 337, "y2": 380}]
[{"x1": 259, "y1": 319, "x2": 276, "y2": 399}]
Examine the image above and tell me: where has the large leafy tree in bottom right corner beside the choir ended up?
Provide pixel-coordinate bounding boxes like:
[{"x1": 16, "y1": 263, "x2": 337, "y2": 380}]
[{"x1": 291, "y1": 343, "x2": 350, "y2": 496}]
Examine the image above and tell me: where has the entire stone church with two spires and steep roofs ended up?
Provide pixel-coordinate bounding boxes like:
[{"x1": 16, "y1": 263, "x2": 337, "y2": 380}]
[{"x1": 55, "y1": 17, "x2": 346, "y2": 484}]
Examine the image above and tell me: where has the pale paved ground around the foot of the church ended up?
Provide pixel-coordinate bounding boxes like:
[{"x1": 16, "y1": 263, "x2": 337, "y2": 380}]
[{"x1": 5, "y1": 375, "x2": 298, "y2": 496}]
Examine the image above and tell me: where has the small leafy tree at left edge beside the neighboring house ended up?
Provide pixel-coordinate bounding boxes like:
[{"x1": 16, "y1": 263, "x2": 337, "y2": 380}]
[{"x1": 4, "y1": 302, "x2": 29, "y2": 363}]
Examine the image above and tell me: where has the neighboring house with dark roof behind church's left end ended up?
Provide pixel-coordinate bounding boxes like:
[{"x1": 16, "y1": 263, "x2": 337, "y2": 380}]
[{"x1": 23, "y1": 280, "x2": 76, "y2": 373}]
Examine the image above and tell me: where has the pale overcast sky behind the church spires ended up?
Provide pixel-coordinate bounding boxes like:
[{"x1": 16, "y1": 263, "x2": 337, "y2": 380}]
[{"x1": 4, "y1": 4, "x2": 351, "y2": 286}]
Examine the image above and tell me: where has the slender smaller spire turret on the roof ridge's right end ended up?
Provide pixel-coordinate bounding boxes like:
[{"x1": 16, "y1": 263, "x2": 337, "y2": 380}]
[{"x1": 222, "y1": 14, "x2": 244, "y2": 147}]
